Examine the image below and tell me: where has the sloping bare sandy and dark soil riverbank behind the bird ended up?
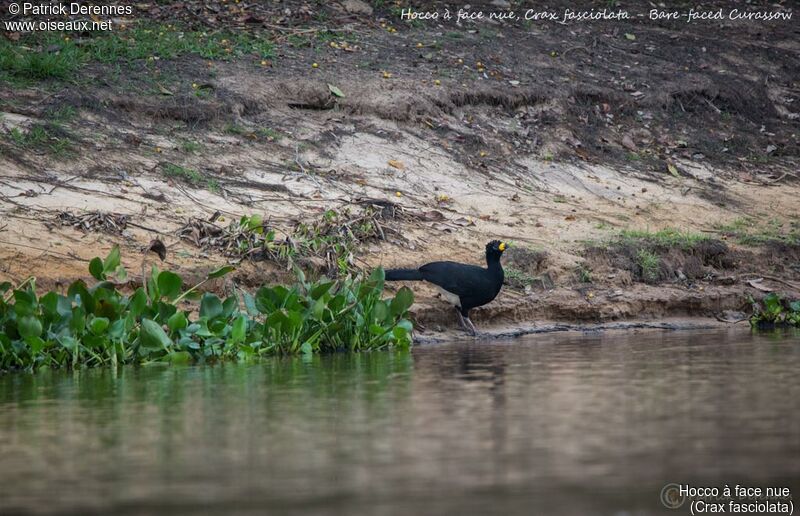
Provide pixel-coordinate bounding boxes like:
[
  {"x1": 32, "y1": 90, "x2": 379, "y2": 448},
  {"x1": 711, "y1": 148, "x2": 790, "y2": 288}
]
[{"x1": 0, "y1": 2, "x2": 800, "y2": 331}]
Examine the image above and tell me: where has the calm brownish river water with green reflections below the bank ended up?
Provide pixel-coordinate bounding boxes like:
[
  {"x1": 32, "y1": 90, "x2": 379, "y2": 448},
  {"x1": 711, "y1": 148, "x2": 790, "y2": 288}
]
[{"x1": 0, "y1": 330, "x2": 800, "y2": 515}]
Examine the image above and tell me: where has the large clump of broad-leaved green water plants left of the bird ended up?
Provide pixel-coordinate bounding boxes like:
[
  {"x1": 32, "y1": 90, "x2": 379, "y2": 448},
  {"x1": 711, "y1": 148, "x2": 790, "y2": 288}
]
[{"x1": 0, "y1": 247, "x2": 414, "y2": 370}]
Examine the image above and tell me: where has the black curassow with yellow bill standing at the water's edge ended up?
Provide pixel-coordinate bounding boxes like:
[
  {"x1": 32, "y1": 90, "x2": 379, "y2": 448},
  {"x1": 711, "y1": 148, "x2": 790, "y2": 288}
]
[{"x1": 386, "y1": 240, "x2": 507, "y2": 335}]
